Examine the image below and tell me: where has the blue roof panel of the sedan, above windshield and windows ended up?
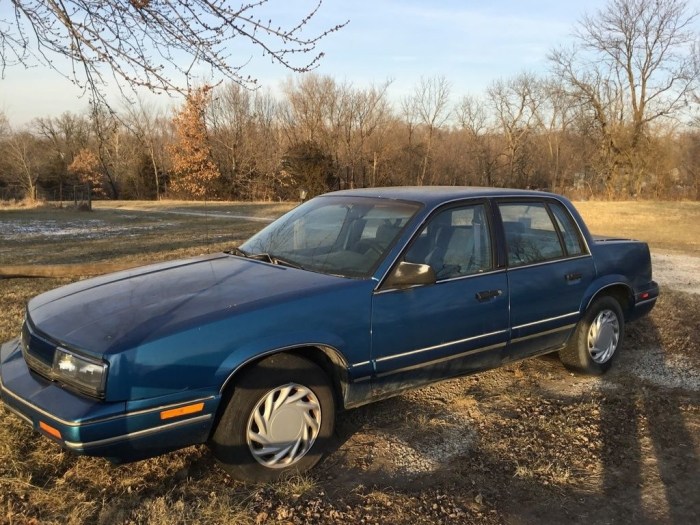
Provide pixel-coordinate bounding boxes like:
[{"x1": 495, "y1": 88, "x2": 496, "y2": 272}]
[{"x1": 326, "y1": 186, "x2": 560, "y2": 206}]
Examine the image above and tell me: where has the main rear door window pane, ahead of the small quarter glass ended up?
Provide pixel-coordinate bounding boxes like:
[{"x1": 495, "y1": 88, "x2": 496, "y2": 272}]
[{"x1": 498, "y1": 202, "x2": 564, "y2": 266}]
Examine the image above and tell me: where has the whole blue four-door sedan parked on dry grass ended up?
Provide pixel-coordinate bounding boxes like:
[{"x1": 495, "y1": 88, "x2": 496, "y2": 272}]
[{"x1": 0, "y1": 187, "x2": 658, "y2": 482}]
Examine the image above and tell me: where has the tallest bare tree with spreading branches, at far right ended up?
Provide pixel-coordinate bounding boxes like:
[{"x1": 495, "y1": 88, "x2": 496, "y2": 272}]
[{"x1": 549, "y1": 0, "x2": 698, "y2": 193}]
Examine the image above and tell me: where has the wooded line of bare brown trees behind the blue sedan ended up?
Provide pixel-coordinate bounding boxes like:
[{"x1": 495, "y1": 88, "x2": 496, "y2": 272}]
[{"x1": 0, "y1": 0, "x2": 700, "y2": 200}]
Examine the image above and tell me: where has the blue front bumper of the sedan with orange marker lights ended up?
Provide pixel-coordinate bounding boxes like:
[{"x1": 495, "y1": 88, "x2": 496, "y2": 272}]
[{"x1": 0, "y1": 339, "x2": 220, "y2": 462}]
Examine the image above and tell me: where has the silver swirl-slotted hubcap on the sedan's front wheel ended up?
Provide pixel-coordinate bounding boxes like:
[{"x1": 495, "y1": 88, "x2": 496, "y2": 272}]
[{"x1": 247, "y1": 383, "x2": 321, "y2": 468}]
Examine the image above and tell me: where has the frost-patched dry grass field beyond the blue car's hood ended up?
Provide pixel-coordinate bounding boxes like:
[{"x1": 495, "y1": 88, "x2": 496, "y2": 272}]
[{"x1": 0, "y1": 203, "x2": 291, "y2": 266}]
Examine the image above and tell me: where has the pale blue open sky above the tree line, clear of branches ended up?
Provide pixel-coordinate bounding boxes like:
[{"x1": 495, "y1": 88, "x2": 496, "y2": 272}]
[{"x1": 0, "y1": 0, "x2": 684, "y2": 128}]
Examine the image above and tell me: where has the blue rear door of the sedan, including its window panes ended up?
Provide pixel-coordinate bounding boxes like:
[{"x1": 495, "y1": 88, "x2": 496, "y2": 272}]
[{"x1": 498, "y1": 199, "x2": 595, "y2": 361}]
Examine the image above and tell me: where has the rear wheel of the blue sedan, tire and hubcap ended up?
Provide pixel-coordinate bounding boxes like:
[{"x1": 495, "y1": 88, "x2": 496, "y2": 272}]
[{"x1": 559, "y1": 296, "x2": 625, "y2": 375}]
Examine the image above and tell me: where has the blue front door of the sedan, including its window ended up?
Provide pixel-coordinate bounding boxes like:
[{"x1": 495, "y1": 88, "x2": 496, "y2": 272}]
[{"x1": 372, "y1": 202, "x2": 508, "y2": 395}]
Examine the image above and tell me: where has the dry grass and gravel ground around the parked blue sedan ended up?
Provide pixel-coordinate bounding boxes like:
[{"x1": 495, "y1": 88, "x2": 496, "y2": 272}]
[{"x1": 0, "y1": 202, "x2": 700, "y2": 524}]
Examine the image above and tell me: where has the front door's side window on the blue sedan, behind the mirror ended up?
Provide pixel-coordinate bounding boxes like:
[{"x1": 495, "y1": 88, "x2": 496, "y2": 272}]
[{"x1": 404, "y1": 204, "x2": 493, "y2": 280}]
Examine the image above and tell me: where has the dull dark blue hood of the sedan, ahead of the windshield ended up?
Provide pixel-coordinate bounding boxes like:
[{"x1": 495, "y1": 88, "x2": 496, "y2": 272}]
[{"x1": 27, "y1": 254, "x2": 351, "y2": 354}]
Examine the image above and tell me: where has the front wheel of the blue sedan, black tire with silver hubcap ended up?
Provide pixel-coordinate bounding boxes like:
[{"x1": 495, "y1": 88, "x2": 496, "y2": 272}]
[{"x1": 209, "y1": 354, "x2": 335, "y2": 483}]
